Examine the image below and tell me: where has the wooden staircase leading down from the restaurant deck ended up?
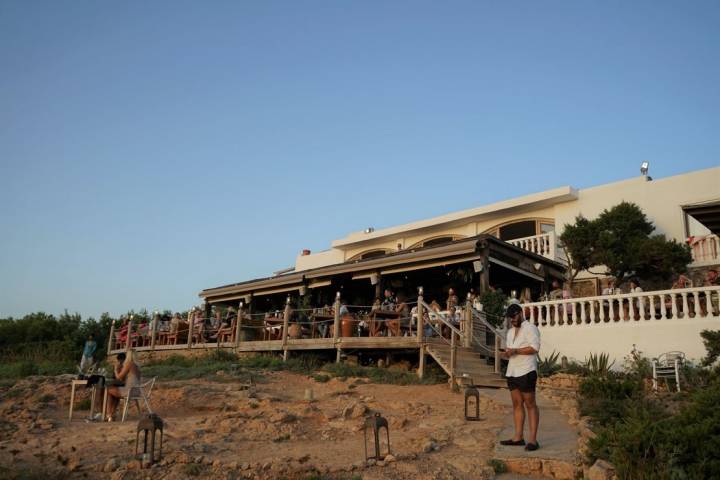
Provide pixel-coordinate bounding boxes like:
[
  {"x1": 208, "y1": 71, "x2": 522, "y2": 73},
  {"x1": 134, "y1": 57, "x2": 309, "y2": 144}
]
[{"x1": 426, "y1": 341, "x2": 507, "y2": 388}]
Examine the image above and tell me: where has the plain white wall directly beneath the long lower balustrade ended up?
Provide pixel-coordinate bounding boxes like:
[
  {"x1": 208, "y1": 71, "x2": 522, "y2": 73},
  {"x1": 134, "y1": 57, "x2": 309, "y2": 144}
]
[{"x1": 538, "y1": 316, "x2": 720, "y2": 367}]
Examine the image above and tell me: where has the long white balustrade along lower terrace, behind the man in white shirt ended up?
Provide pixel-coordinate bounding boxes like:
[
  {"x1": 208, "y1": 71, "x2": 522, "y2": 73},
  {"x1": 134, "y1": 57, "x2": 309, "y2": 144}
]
[{"x1": 522, "y1": 287, "x2": 720, "y2": 327}]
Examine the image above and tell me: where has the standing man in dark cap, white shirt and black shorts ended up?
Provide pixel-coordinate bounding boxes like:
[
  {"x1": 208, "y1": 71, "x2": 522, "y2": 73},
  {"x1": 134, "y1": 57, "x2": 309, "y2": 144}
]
[{"x1": 500, "y1": 303, "x2": 540, "y2": 450}]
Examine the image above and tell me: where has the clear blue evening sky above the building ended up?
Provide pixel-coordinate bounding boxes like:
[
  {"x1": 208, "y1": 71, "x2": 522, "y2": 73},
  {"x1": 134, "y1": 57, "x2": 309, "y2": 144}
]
[{"x1": 0, "y1": 0, "x2": 720, "y2": 316}]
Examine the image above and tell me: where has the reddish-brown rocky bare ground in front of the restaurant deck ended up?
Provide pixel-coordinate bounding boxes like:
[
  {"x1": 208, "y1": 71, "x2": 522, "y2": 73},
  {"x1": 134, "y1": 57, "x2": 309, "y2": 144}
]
[{"x1": 0, "y1": 372, "x2": 580, "y2": 480}]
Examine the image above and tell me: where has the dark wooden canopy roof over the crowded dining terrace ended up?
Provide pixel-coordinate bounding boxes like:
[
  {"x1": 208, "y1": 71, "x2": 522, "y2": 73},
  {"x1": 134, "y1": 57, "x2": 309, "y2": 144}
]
[{"x1": 200, "y1": 234, "x2": 565, "y2": 311}]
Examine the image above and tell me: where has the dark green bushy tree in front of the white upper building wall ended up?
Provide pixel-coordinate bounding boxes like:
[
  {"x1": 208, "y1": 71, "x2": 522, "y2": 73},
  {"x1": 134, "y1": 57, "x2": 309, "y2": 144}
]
[{"x1": 560, "y1": 202, "x2": 692, "y2": 285}]
